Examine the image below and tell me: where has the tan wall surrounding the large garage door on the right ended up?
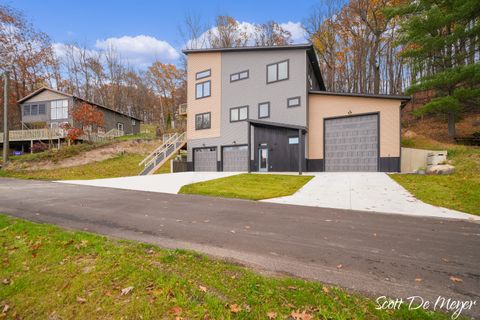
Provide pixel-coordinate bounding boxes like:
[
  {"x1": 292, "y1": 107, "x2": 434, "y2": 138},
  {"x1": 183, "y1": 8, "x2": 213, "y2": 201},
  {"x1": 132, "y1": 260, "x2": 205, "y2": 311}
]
[{"x1": 308, "y1": 94, "x2": 401, "y2": 159}]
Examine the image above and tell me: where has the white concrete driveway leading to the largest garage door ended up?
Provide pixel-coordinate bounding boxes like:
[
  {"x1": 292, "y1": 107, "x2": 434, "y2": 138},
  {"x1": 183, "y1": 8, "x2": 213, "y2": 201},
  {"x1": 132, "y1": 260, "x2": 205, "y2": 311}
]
[{"x1": 264, "y1": 172, "x2": 480, "y2": 221}]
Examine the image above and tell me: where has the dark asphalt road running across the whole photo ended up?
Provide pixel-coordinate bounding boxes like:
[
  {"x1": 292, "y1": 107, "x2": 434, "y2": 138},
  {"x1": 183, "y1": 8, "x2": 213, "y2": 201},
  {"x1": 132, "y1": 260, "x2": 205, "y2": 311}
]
[{"x1": 0, "y1": 179, "x2": 480, "y2": 315}]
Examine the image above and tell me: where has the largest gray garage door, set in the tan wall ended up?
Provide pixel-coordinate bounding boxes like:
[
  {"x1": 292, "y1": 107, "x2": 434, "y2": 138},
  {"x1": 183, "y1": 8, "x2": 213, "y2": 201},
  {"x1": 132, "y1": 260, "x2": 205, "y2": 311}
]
[{"x1": 324, "y1": 114, "x2": 378, "y2": 171}]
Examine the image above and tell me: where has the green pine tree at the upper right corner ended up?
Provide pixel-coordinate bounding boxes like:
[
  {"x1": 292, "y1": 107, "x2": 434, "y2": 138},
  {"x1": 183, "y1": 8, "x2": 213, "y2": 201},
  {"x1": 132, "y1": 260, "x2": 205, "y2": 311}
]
[{"x1": 388, "y1": 0, "x2": 480, "y2": 137}]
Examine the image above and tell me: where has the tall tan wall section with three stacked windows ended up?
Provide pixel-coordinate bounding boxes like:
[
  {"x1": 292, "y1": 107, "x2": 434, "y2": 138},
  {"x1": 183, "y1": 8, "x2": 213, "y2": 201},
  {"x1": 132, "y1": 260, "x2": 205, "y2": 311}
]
[{"x1": 187, "y1": 52, "x2": 222, "y2": 139}]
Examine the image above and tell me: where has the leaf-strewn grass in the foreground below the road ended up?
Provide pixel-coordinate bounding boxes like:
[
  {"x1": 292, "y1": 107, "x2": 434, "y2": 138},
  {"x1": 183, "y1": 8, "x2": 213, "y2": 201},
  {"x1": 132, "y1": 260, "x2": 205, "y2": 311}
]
[{"x1": 0, "y1": 215, "x2": 449, "y2": 319}]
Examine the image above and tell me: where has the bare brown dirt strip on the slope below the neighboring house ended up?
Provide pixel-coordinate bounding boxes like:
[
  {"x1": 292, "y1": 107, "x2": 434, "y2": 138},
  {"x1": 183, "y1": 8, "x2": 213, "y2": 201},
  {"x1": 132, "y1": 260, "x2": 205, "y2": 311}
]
[{"x1": 9, "y1": 140, "x2": 161, "y2": 170}]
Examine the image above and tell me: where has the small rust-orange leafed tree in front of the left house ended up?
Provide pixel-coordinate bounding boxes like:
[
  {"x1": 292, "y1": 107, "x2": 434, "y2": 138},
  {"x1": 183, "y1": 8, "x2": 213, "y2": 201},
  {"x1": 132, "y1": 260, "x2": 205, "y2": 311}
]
[{"x1": 70, "y1": 102, "x2": 105, "y2": 139}]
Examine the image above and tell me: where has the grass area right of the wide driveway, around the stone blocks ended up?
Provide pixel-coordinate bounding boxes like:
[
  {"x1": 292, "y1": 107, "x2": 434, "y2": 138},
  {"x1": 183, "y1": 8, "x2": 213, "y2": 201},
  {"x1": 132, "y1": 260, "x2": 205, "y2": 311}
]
[{"x1": 390, "y1": 139, "x2": 480, "y2": 215}]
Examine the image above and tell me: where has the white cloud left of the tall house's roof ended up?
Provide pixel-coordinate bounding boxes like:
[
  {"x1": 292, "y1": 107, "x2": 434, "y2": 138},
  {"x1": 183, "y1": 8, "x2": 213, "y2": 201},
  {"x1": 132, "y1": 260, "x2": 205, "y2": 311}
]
[{"x1": 95, "y1": 35, "x2": 180, "y2": 67}]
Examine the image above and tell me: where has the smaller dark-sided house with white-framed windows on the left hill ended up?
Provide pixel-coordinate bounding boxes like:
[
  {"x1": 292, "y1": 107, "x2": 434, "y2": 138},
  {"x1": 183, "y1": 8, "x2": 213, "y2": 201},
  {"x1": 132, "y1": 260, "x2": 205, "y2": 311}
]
[{"x1": 18, "y1": 87, "x2": 141, "y2": 134}]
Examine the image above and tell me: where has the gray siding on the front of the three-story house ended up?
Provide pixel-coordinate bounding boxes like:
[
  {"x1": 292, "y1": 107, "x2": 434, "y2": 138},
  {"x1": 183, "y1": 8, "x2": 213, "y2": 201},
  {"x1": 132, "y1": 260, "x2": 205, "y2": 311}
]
[{"x1": 188, "y1": 50, "x2": 308, "y2": 161}]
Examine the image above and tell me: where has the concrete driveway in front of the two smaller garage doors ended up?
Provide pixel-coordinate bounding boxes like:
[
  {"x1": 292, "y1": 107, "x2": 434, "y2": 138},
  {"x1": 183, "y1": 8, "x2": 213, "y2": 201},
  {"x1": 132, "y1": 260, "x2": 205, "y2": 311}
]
[{"x1": 57, "y1": 172, "x2": 239, "y2": 194}]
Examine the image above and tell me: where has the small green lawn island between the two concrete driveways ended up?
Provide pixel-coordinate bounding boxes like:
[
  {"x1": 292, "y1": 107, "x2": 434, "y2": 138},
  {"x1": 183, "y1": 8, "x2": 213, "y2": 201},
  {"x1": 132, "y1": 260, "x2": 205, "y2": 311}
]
[{"x1": 179, "y1": 174, "x2": 313, "y2": 200}]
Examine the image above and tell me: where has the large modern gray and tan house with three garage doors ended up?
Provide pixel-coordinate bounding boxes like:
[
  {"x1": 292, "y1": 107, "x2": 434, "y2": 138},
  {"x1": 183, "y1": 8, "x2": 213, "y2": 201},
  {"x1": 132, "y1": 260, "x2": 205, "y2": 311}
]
[{"x1": 184, "y1": 44, "x2": 409, "y2": 172}]
